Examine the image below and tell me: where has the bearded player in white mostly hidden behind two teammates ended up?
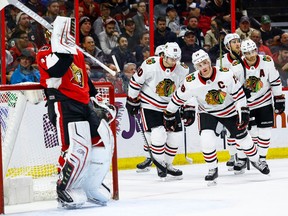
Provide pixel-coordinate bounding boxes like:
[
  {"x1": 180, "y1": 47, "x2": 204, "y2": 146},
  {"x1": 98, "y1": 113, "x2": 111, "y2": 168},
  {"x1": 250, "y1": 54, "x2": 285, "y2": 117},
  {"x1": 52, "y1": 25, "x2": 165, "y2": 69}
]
[{"x1": 216, "y1": 33, "x2": 241, "y2": 170}]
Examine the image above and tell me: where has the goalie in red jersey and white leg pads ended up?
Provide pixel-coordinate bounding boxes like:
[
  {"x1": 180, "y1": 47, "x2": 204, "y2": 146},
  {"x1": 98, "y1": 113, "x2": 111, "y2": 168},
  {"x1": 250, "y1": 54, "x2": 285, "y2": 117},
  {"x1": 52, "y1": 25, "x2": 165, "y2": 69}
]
[{"x1": 37, "y1": 16, "x2": 116, "y2": 208}]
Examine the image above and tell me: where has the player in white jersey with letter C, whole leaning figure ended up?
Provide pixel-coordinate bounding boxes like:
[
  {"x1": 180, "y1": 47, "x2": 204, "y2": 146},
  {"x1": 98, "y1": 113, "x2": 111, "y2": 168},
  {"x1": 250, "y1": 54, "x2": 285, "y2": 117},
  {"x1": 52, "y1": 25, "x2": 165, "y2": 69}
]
[{"x1": 164, "y1": 50, "x2": 269, "y2": 184}]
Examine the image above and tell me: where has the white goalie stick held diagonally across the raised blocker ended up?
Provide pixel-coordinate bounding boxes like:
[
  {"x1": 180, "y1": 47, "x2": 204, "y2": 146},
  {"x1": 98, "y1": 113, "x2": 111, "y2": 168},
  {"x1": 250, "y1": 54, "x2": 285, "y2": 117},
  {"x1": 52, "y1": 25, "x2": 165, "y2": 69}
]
[{"x1": 0, "y1": 0, "x2": 116, "y2": 76}]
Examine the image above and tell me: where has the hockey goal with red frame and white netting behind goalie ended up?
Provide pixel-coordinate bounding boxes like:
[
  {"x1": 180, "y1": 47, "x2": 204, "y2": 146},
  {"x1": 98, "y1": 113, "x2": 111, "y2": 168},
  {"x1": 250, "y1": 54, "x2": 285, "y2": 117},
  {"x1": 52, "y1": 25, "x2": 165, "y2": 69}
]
[{"x1": 0, "y1": 82, "x2": 119, "y2": 214}]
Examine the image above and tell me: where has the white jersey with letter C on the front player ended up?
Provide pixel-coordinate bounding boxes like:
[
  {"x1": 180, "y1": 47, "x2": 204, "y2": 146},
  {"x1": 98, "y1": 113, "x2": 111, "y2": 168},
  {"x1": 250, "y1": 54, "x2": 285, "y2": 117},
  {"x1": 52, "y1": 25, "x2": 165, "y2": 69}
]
[{"x1": 167, "y1": 66, "x2": 247, "y2": 118}]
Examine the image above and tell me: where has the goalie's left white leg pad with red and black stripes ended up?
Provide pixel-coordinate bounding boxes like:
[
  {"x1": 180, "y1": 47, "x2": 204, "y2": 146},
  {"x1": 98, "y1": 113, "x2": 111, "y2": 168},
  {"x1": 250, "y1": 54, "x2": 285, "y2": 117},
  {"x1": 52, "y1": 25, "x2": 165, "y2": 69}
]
[{"x1": 57, "y1": 121, "x2": 91, "y2": 190}]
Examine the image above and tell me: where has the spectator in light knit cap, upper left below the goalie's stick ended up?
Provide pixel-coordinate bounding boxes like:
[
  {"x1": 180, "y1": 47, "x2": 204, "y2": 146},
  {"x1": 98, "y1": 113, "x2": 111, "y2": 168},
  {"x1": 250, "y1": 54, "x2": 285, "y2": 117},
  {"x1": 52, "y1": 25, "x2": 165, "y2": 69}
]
[{"x1": 11, "y1": 12, "x2": 46, "y2": 48}]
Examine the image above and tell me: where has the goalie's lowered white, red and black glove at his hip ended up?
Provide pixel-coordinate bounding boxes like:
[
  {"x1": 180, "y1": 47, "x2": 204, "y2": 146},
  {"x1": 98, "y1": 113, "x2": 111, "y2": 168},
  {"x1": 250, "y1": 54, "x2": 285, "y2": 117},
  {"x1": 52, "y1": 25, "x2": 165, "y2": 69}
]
[{"x1": 90, "y1": 95, "x2": 117, "y2": 124}]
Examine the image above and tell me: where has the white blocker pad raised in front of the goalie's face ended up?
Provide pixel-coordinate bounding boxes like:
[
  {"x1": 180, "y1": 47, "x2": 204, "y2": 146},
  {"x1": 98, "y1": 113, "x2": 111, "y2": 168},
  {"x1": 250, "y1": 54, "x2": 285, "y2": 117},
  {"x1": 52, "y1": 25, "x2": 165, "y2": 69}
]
[{"x1": 51, "y1": 16, "x2": 77, "y2": 55}]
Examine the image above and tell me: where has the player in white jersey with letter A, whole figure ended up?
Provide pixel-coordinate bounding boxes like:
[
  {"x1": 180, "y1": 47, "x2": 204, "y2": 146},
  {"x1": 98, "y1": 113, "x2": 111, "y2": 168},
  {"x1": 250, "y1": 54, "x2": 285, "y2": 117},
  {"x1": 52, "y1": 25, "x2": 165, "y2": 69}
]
[{"x1": 232, "y1": 39, "x2": 285, "y2": 172}]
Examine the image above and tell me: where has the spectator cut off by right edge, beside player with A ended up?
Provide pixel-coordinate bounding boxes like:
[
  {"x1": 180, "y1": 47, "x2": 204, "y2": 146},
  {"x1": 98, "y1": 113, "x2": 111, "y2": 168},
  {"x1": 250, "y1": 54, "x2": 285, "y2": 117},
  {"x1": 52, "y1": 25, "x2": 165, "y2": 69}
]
[{"x1": 273, "y1": 45, "x2": 288, "y2": 87}]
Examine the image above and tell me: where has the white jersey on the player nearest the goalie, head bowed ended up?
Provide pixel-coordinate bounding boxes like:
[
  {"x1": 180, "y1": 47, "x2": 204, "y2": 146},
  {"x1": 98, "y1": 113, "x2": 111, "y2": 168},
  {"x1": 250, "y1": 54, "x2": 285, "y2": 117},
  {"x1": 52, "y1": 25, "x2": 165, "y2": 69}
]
[{"x1": 128, "y1": 56, "x2": 189, "y2": 111}]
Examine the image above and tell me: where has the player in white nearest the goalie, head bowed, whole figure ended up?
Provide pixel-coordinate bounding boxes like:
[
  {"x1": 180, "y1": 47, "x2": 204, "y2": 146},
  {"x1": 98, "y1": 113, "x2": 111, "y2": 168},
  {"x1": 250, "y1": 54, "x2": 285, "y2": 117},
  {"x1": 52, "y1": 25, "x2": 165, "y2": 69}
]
[{"x1": 126, "y1": 43, "x2": 189, "y2": 178}]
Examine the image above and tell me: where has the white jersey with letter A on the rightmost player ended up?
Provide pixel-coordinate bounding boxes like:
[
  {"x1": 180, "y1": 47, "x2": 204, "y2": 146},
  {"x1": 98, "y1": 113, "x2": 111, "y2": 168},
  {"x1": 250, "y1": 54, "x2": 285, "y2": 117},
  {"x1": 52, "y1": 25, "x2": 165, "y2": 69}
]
[{"x1": 232, "y1": 55, "x2": 282, "y2": 110}]
